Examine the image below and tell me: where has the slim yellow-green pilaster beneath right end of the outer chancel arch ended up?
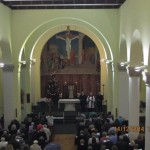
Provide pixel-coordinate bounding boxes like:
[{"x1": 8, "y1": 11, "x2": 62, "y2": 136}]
[{"x1": 105, "y1": 63, "x2": 113, "y2": 113}]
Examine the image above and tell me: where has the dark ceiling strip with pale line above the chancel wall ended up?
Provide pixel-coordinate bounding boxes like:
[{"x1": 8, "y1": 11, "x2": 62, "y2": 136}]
[{"x1": 0, "y1": 0, "x2": 126, "y2": 9}]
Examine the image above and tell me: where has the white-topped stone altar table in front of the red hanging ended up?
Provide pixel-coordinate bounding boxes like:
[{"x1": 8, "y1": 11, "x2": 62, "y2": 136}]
[{"x1": 58, "y1": 99, "x2": 80, "y2": 111}]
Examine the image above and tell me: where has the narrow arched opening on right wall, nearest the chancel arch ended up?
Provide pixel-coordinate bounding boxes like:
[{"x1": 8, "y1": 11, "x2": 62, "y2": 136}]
[{"x1": 119, "y1": 35, "x2": 128, "y2": 62}]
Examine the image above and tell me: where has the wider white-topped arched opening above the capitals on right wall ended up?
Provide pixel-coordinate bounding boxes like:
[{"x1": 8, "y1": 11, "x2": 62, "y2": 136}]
[{"x1": 130, "y1": 30, "x2": 143, "y2": 66}]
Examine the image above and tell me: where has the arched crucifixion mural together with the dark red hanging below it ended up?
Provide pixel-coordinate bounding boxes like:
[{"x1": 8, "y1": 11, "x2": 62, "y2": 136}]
[{"x1": 41, "y1": 28, "x2": 100, "y2": 98}]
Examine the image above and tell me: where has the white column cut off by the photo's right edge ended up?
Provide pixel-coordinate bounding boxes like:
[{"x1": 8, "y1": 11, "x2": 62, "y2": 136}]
[{"x1": 145, "y1": 72, "x2": 150, "y2": 150}]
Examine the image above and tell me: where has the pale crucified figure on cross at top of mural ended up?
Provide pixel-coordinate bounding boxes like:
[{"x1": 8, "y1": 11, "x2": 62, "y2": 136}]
[{"x1": 56, "y1": 26, "x2": 79, "y2": 59}]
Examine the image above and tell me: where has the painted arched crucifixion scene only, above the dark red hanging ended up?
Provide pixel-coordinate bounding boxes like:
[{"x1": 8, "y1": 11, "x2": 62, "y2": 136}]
[{"x1": 41, "y1": 29, "x2": 100, "y2": 75}]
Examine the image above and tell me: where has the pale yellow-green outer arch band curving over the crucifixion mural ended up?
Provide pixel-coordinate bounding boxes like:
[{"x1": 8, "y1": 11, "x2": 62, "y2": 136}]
[{"x1": 19, "y1": 18, "x2": 113, "y2": 59}]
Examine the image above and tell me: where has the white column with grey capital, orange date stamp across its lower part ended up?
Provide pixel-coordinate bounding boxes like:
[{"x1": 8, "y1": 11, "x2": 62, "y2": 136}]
[{"x1": 128, "y1": 67, "x2": 141, "y2": 140}]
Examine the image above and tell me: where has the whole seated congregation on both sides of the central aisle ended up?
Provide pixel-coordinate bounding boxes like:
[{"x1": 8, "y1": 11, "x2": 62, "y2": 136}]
[{"x1": 0, "y1": 108, "x2": 145, "y2": 150}]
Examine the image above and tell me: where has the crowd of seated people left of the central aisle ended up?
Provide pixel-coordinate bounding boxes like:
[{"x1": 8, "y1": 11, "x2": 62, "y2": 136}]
[{"x1": 0, "y1": 113, "x2": 61, "y2": 150}]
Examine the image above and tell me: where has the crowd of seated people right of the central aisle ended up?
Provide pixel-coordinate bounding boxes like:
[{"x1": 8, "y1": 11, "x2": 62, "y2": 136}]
[{"x1": 75, "y1": 112, "x2": 145, "y2": 150}]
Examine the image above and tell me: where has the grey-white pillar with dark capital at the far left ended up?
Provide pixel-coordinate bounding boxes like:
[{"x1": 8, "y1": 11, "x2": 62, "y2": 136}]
[{"x1": 2, "y1": 64, "x2": 17, "y2": 129}]
